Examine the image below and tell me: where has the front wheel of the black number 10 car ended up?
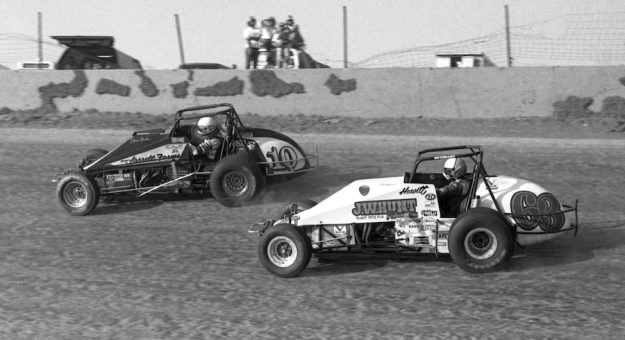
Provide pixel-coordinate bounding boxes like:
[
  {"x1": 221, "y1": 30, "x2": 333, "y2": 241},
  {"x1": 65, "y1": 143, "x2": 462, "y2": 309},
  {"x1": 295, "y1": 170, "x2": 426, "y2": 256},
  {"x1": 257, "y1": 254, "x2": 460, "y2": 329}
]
[{"x1": 56, "y1": 173, "x2": 100, "y2": 216}]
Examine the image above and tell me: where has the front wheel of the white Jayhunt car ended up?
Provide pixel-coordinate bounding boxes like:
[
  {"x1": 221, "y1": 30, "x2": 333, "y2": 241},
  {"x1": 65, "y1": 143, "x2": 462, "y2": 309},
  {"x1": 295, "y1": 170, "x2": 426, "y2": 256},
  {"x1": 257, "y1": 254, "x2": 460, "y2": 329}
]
[{"x1": 258, "y1": 224, "x2": 312, "y2": 277}]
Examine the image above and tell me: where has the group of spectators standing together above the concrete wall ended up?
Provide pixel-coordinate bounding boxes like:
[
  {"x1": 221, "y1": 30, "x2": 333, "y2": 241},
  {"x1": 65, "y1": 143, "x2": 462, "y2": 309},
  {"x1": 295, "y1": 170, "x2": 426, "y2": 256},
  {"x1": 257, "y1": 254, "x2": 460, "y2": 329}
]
[{"x1": 243, "y1": 15, "x2": 305, "y2": 69}]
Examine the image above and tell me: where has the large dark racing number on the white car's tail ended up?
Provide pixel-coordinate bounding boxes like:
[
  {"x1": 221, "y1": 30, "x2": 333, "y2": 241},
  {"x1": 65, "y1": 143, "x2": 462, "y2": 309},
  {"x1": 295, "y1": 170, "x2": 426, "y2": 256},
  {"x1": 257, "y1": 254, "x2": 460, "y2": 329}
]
[{"x1": 510, "y1": 191, "x2": 565, "y2": 232}]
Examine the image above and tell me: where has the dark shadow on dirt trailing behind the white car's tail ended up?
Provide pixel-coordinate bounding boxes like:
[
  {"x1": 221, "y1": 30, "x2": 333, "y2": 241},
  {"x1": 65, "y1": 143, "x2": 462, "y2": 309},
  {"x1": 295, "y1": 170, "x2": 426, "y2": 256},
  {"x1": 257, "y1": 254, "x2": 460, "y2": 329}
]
[{"x1": 509, "y1": 221, "x2": 625, "y2": 271}]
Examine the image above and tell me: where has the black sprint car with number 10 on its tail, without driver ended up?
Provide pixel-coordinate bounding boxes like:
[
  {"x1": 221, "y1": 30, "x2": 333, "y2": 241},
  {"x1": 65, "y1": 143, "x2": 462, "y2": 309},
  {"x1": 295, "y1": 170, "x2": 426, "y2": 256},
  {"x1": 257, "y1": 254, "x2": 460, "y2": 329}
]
[{"x1": 53, "y1": 103, "x2": 316, "y2": 215}]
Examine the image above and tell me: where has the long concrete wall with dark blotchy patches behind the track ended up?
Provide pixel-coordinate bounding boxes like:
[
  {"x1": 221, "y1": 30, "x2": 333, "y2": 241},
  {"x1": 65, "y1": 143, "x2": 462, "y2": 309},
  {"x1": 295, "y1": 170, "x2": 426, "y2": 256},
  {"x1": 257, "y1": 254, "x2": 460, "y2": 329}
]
[{"x1": 0, "y1": 66, "x2": 625, "y2": 118}]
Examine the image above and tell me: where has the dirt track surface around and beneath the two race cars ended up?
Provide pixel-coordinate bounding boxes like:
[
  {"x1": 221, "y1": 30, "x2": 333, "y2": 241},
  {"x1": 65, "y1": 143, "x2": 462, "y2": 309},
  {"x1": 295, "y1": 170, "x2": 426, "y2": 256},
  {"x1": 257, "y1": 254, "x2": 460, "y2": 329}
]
[{"x1": 0, "y1": 128, "x2": 625, "y2": 339}]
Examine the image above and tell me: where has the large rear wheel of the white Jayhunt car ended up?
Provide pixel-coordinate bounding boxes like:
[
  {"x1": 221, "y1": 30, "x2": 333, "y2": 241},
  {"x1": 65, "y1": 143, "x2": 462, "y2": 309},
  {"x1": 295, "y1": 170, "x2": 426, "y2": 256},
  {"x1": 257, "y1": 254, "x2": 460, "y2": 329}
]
[{"x1": 449, "y1": 208, "x2": 514, "y2": 273}]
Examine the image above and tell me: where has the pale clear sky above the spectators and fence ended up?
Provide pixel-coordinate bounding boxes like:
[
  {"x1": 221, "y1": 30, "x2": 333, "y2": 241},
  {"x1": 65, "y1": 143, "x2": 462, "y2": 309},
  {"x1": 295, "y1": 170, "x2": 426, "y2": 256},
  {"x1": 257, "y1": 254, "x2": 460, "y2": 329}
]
[{"x1": 0, "y1": 0, "x2": 625, "y2": 69}]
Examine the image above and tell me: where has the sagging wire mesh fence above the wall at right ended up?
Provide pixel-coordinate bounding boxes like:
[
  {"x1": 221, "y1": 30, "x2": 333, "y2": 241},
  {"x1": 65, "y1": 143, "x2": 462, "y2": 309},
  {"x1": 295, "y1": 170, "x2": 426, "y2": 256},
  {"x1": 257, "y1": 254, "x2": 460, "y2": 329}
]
[{"x1": 352, "y1": 12, "x2": 625, "y2": 67}]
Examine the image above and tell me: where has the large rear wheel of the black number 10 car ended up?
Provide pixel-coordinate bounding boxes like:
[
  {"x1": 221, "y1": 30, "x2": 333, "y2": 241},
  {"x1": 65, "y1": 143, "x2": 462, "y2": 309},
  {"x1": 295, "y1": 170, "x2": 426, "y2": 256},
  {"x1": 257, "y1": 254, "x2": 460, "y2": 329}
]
[{"x1": 210, "y1": 152, "x2": 263, "y2": 207}]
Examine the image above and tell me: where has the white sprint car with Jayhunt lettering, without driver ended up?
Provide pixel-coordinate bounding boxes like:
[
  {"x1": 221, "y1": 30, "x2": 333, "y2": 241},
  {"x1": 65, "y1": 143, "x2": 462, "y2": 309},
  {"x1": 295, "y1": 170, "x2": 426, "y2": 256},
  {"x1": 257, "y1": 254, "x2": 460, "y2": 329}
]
[{"x1": 250, "y1": 146, "x2": 578, "y2": 277}]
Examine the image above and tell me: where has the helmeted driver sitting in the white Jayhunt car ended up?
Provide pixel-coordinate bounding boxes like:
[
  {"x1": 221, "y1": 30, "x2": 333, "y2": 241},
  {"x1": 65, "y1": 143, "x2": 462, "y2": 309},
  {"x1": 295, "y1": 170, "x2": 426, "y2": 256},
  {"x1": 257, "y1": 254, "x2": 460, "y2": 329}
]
[{"x1": 436, "y1": 158, "x2": 471, "y2": 217}]
